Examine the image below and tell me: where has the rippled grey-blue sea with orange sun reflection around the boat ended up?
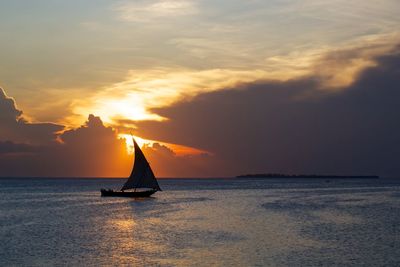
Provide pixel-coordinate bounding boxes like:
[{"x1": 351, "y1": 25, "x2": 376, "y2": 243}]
[{"x1": 0, "y1": 178, "x2": 400, "y2": 266}]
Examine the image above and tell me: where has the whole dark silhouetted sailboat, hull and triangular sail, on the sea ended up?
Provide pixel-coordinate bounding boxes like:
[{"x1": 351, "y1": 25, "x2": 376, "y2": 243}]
[{"x1": 100, "y1": 137, "x2": 162, "y2": 197}]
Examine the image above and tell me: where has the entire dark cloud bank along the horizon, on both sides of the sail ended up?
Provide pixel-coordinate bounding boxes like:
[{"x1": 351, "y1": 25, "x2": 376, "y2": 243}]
[{"x1": 0, "y1": 48, "x2": 400, "y2": 176}]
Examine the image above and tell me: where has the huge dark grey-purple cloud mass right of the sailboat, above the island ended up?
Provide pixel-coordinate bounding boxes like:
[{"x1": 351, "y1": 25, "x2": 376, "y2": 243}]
[{"x1": 136, "y1": 45, "x2": 400, "y2": 176}]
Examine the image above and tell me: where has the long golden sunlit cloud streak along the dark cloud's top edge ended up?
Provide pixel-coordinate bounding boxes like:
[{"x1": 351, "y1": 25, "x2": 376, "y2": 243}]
[{"x1": 72, "y1": 35, "x2": 399, "y2": 126}]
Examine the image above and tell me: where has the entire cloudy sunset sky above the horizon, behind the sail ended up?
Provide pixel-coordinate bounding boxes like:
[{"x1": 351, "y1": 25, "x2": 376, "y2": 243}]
[{"x1": 0, "y1": 0, "x2": 400, "y2": 177}]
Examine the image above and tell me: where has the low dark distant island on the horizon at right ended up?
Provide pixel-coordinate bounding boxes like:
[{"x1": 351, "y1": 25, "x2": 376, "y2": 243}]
[{"x1": 236, "y1": 173, "x2": 379, "y2": 179}]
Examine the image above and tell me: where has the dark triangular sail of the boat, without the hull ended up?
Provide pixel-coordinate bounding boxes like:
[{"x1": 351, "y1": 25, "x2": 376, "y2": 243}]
[{"x1": 121, "y1": 139, "x2": 161, "y2": 191}]
